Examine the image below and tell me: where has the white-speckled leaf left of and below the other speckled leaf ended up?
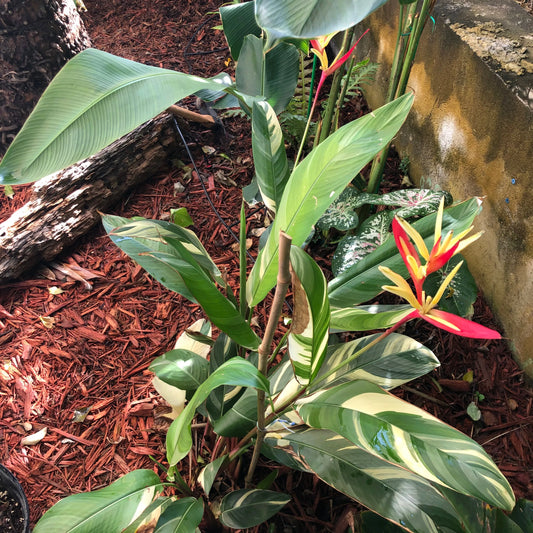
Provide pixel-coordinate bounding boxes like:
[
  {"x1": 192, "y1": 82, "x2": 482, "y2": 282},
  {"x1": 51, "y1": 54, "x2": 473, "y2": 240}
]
[{"x1": 331, "y1": 211, "x2": 394, "y2": 276}]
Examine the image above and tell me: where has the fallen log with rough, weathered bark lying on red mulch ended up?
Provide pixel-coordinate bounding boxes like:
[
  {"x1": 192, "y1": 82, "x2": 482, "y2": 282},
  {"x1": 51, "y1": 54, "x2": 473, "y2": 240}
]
[{"x1": 0, "y1": 114, "x2": 185, "y2": 282}]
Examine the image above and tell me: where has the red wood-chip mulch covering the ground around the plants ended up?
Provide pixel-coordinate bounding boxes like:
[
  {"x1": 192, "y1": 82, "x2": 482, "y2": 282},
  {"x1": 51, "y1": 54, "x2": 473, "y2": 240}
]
[{"x1": 0, "y1": 0, "x2": 533, "y2": 531}]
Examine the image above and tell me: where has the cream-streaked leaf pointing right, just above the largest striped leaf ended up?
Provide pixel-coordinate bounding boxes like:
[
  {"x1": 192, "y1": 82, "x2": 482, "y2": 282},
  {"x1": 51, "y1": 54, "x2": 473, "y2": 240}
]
[{"x1": 311, "y1": 333, "x2": 440, "y2": 392}]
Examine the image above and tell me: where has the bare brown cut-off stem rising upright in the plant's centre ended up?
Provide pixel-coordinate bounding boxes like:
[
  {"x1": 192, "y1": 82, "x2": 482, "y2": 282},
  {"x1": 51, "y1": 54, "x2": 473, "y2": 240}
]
[{"x1": 245, "y1": 231, "x2": 292, "y2": 486}]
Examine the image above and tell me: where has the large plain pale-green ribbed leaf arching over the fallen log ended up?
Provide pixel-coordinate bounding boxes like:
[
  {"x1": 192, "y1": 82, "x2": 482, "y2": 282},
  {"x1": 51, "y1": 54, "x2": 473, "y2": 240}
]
[{"x1": 0, "y1": 49, "x2": 231, "y2": 185}]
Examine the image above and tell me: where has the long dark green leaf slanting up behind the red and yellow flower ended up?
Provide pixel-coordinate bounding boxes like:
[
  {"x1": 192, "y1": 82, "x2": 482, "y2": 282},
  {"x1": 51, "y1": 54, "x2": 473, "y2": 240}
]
[{"x1": 328, "y1": 198, "x2": 481, "y2": 308}]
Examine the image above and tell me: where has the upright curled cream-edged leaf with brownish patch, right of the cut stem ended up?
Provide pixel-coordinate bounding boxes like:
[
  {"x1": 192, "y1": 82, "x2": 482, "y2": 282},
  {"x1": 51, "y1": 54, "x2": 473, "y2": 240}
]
[{"x1": 287, "y1": 246, "x2": 329, "y2": 385}]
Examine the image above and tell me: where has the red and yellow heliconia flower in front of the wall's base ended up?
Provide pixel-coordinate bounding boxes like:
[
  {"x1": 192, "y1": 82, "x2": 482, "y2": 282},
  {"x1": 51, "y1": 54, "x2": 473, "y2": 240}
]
[{"x1": 378, "y1": 198, "x2": 501, "y2": 339}]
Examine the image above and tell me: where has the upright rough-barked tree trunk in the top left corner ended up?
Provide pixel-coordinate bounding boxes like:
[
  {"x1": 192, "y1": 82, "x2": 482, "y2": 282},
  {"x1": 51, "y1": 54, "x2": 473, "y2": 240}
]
[{"x1": 0, "y1": 0, "x2": 90, "y2": 156}]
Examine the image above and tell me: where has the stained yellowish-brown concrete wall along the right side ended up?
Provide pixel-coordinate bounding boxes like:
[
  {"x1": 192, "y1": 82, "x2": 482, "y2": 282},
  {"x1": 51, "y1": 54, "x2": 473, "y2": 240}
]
[{"x1": 358, "y1": 0, "x2": 533, "y2": 377}]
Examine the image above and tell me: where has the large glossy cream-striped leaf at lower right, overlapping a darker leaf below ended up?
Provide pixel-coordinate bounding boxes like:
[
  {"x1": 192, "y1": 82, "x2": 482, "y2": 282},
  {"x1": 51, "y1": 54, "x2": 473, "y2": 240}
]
[{"x1": 296, "y1": 380, "x2": 515, "y2": 510}]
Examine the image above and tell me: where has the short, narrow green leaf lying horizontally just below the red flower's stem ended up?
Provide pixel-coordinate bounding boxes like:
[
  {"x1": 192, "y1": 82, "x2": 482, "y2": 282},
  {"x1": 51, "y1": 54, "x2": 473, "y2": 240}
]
[{"x1": 329, "y1": 305, "x2": 412, "y2": 332}]
